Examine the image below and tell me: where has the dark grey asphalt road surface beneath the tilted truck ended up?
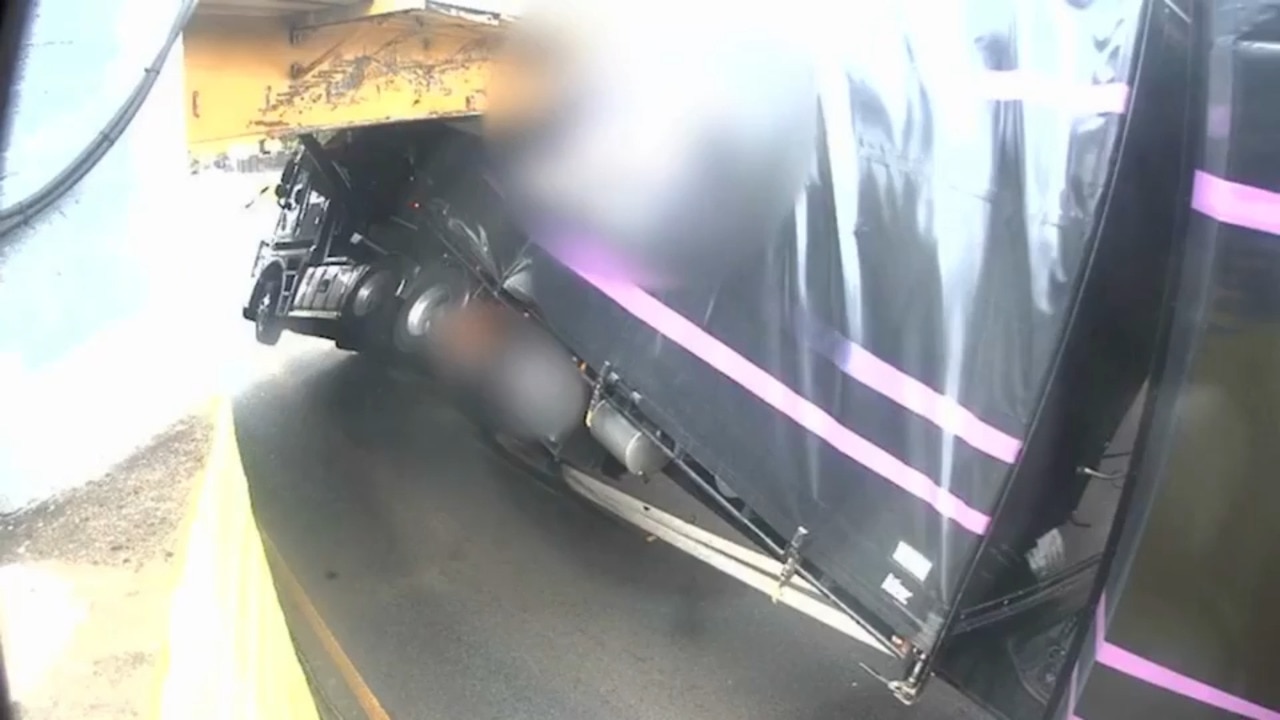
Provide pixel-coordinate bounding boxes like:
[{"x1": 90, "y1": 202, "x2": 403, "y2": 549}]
[{"x1": 236, "y1": 340, "x2": 978, "y2": 720}]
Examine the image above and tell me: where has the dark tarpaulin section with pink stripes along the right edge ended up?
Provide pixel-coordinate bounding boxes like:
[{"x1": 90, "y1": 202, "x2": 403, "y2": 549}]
[{"x1": 1059, "y1": 1, "x2": 1280, "y2": 720}]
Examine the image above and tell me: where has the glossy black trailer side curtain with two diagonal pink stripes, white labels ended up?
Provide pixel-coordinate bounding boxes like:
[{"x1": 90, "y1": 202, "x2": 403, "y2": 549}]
[{"x1": 538, "y1": 0, "x2": 1142, "y2": 650}]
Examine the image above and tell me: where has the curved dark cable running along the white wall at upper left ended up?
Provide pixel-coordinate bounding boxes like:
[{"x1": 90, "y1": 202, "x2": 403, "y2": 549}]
[{"x1": 0, "y1": 0, "x2": 196, "y2": 240}]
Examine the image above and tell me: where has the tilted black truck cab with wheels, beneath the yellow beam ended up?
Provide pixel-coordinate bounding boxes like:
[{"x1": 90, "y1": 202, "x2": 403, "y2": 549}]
[{"x1": 243, "y1": 120, "x2": 532, "y2": 355}]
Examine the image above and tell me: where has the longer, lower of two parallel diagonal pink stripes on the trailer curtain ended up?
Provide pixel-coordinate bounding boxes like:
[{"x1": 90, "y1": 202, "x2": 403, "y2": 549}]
[{"x1": 570, "y1": 266, "x2": 991, "y2": 536}]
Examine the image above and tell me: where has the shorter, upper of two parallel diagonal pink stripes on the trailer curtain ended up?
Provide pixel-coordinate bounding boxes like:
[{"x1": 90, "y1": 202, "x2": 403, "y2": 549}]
[{"x1": 808, "y1": 337, "x2": 1023, "y2": 464}]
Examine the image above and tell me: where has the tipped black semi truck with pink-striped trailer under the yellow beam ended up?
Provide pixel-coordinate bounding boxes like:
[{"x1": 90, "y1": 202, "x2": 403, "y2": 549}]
[{"x1": 222, "y1": 0, "x2": 1280, "y2": 720}]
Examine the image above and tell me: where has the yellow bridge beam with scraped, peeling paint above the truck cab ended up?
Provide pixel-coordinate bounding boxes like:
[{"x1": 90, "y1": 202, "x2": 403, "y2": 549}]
[{"x1": 183, "y1": 6, "x2": 503, "y2": 156}]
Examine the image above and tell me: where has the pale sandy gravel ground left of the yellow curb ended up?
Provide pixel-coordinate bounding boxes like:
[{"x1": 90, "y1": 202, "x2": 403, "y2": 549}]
[{"x1": 0, "y1": 416, "x2": 211, "y2": 720}]
